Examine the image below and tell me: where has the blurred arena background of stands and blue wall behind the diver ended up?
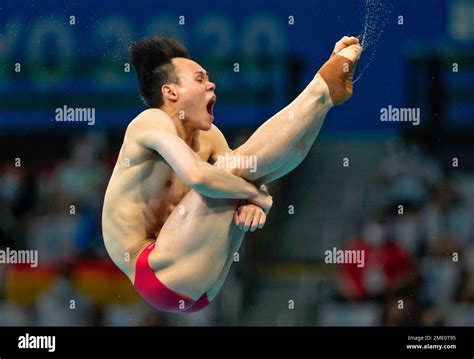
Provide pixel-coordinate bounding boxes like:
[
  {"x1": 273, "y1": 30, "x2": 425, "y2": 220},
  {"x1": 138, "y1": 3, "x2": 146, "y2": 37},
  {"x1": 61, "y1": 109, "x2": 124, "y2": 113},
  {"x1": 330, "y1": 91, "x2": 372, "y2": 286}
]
[{"x1": 0, "y1": 0, "x2": 474, "y2": 326}]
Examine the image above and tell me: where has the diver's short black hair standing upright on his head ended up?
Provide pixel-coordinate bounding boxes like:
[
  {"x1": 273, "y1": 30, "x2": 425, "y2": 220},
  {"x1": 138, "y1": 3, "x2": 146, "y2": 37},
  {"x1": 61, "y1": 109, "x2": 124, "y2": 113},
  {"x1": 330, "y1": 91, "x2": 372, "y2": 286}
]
[{"x1": 129, "y1": 36, "x2": 189, "y2": 108}]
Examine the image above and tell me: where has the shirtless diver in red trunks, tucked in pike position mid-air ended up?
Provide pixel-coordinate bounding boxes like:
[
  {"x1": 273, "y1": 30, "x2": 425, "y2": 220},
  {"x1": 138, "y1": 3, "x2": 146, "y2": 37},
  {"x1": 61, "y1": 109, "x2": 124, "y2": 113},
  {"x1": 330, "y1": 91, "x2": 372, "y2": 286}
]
[{"x1": 102, "y1": 36, "x2": 362, "y2": 312}]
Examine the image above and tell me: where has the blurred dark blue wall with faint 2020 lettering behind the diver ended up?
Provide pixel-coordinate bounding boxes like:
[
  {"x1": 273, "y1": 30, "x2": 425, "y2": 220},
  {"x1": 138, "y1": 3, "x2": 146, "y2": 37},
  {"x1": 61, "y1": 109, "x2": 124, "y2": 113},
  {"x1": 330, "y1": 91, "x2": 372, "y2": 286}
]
[{"x1": 0, "y1": 0, "x2": 462, "y2": 134}]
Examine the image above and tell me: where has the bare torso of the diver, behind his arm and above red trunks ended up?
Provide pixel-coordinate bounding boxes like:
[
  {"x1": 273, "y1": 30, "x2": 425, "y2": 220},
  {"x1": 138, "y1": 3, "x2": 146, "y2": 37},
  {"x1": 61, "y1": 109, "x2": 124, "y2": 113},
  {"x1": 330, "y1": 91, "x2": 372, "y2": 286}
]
[{"x1": 102, "y1": 109, "x2": 212, "y2": 281}]
